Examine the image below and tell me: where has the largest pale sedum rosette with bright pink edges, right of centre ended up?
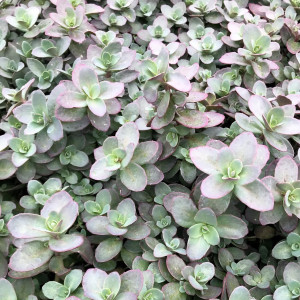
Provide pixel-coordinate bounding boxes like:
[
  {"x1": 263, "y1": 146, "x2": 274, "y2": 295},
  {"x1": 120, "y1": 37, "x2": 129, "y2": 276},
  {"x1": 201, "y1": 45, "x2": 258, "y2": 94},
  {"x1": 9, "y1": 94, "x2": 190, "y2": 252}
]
[{"x1": 190, "y1": 133, "x2": 274, "y2": 211}]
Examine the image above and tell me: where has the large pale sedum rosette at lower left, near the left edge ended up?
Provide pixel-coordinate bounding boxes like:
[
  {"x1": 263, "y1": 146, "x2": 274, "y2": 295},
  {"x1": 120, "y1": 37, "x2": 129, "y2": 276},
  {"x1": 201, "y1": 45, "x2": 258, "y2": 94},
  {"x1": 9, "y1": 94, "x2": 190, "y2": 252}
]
[{"x1": 7, "y1": 191, "x2": 84, "y2": 273}]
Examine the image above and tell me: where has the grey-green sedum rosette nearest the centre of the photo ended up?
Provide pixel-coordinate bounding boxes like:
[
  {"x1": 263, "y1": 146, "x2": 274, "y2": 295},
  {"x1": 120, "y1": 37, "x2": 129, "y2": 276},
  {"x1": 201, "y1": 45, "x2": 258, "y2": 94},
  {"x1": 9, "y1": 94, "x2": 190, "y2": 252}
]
[{"x1": 90, "y1": 122, "x2": 163, "y2": 192}]
